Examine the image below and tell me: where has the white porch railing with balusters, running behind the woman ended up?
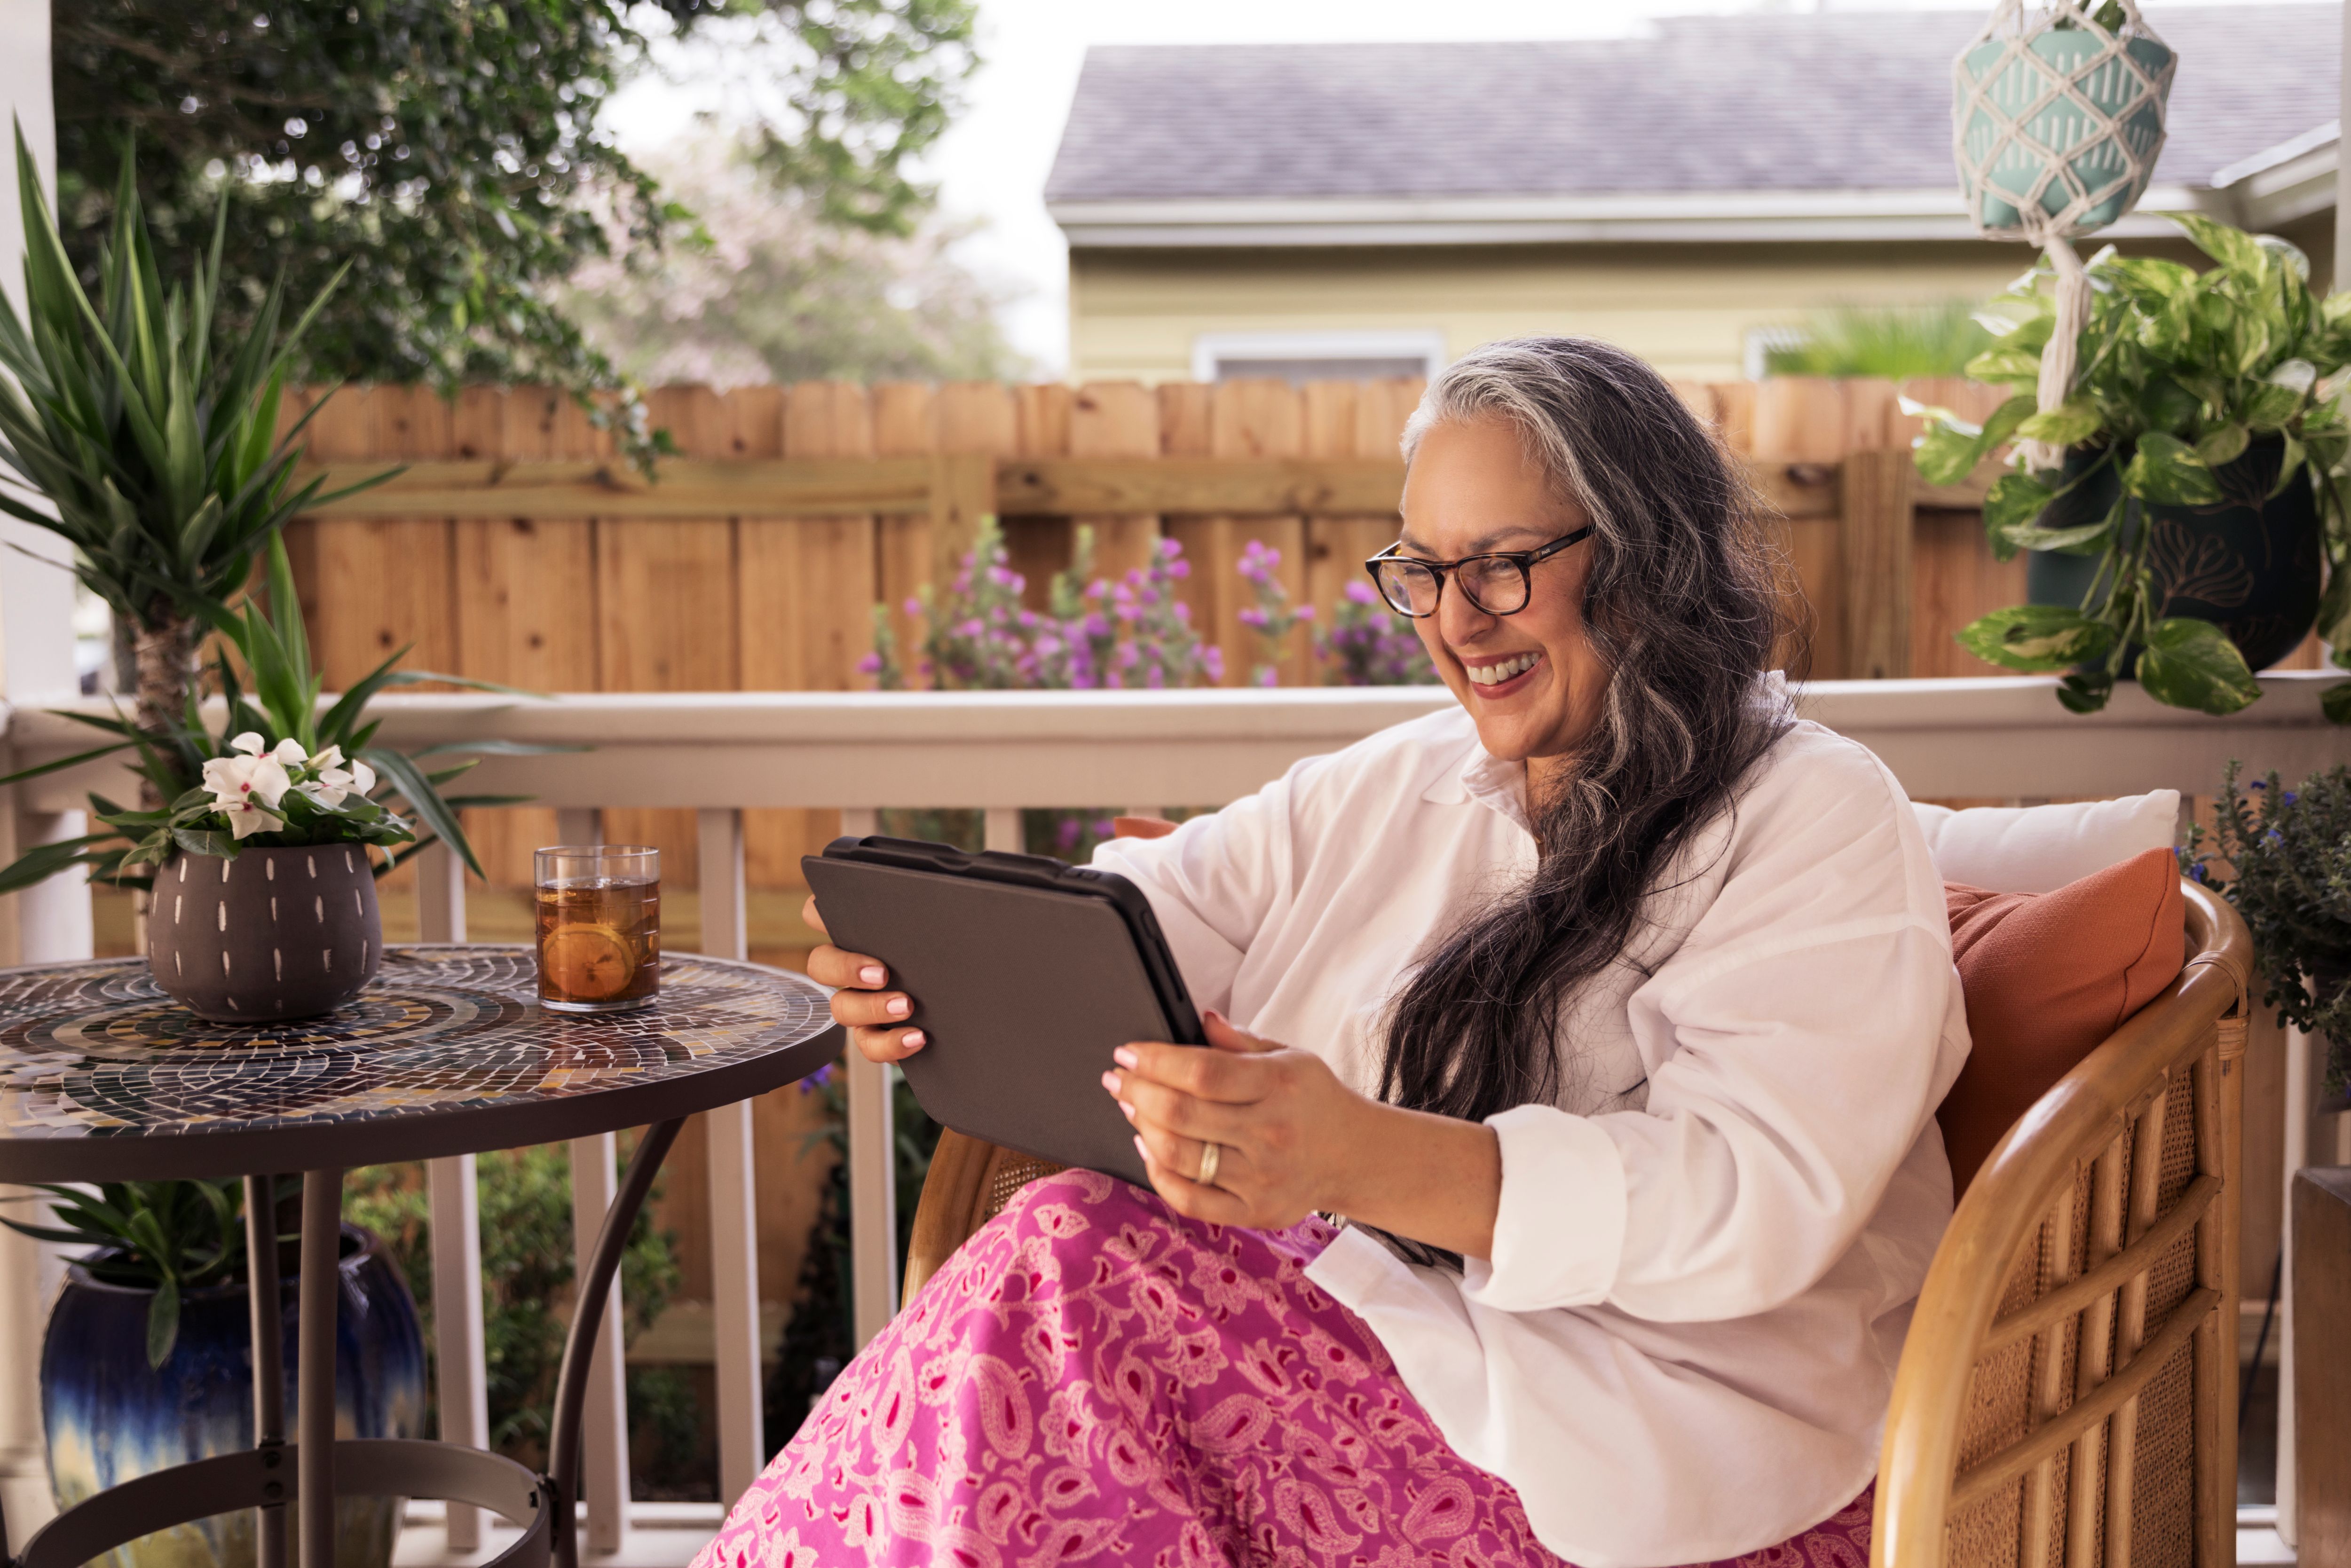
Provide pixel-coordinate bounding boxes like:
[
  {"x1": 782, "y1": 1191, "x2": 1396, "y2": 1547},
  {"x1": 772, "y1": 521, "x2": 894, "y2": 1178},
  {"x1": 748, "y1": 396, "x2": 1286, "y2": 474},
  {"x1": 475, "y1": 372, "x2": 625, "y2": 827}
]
[{"x1": 0, "y1": 672, "x2": 2351, "y2": 1563}]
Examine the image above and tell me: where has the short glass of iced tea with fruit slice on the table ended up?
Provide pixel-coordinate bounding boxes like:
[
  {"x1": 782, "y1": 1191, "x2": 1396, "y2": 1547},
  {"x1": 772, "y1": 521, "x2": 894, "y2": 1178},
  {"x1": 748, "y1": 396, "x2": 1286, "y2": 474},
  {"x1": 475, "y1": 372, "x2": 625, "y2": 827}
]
[{"x1": 534, "y1": 844, "x2": 661, "y2": 1013}]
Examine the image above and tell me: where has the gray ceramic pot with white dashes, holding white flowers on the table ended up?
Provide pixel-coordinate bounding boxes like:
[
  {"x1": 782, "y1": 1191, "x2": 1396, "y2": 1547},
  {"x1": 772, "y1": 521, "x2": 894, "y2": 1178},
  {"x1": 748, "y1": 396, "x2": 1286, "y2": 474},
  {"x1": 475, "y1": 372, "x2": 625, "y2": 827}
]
[{"x1": 148, "y1": 844, "x2": 383, "y2": 1023}]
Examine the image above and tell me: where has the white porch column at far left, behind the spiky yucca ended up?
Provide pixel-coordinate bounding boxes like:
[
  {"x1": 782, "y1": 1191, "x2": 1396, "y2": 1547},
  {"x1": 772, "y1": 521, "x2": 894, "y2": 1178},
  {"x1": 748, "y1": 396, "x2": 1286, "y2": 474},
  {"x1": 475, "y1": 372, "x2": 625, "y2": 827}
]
[{"x1": 0, "y1": 0, "x2": 63, "y2": 1552}]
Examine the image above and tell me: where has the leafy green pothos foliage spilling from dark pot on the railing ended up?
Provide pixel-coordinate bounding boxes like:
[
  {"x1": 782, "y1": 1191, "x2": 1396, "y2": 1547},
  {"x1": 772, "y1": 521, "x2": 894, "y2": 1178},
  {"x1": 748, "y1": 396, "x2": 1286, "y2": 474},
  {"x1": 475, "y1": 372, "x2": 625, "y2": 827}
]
[{"x1": 1904, "y1": 214, "x2": 2351, "y2": 722}]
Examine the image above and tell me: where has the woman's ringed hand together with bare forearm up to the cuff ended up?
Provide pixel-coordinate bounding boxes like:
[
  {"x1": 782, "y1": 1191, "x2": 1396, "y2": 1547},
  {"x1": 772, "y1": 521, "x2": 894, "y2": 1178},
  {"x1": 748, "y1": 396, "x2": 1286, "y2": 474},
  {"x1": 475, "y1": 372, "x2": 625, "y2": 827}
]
[{"x1": 1105, "y1": 1011, "x2": 1502, "y2": 1258}]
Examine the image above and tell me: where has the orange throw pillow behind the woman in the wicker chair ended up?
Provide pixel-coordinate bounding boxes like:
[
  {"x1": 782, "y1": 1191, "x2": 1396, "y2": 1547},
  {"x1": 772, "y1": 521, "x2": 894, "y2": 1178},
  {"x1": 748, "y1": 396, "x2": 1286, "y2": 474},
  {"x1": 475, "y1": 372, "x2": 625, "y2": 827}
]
[{"x1": 1935, "y1": 849, "x2": 2186, "y2": 1194}]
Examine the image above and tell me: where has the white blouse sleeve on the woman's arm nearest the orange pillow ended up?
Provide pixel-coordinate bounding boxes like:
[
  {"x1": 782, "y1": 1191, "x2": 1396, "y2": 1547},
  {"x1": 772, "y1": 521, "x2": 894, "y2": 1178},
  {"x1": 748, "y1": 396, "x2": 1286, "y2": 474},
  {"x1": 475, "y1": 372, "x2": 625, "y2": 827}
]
[{"x1": 1462, "y1": 748, "x2": 1965, "y2": 1321}]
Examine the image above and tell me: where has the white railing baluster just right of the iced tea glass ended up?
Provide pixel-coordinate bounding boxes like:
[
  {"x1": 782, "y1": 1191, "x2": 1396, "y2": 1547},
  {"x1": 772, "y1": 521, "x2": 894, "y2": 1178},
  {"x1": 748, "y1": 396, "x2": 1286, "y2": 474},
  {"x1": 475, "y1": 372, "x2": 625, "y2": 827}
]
[{"x1": 698, "y1": 811, "x2": 766, "y2": 1502}]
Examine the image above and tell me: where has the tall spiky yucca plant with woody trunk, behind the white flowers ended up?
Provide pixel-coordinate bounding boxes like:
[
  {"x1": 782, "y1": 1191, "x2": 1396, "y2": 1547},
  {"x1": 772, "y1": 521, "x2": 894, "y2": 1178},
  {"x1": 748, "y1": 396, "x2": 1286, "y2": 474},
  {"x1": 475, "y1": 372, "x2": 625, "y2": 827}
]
[{"x1": 0, "y1": 127, "x2": 397, "y2": 752}]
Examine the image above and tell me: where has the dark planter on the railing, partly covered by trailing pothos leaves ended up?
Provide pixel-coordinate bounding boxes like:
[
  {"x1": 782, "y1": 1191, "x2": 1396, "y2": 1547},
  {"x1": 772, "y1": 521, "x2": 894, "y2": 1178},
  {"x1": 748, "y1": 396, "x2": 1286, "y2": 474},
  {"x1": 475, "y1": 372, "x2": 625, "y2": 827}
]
[{"x1": 2024, "y1": 437, "x2": 2320, "y2": 670}]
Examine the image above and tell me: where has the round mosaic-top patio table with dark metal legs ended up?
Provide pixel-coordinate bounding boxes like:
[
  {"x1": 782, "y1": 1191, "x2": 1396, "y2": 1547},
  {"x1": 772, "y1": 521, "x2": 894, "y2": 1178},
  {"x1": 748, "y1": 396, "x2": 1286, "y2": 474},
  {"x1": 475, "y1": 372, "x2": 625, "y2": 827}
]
[{"x1": 0, "y1": 943, "x2": 842, "y2": 1568}]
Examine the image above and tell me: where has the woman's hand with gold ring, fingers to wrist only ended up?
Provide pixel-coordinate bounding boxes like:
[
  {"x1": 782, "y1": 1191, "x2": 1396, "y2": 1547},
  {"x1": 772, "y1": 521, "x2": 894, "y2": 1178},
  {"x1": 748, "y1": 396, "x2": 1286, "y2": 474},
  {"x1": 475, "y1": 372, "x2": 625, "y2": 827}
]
[{"x1": 1103, "y1": 1013, "x2": 1373, "y2": 1229}]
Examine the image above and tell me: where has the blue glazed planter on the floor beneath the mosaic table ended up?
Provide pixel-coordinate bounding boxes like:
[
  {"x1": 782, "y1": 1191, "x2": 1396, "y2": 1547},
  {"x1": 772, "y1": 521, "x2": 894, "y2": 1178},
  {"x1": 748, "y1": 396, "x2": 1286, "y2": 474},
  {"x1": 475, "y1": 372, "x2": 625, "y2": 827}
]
[{"x1": 40, "y1": 1225, "x2": 426, "y2": 1568}]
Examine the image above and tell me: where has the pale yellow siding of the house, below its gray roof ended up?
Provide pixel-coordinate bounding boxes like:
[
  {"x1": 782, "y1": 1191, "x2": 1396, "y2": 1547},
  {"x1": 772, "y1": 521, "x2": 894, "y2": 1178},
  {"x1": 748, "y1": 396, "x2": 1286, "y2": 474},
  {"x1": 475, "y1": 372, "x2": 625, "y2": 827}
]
[{"x1": 1070, "y1": 214, "x2": 2332, "y2": 381}]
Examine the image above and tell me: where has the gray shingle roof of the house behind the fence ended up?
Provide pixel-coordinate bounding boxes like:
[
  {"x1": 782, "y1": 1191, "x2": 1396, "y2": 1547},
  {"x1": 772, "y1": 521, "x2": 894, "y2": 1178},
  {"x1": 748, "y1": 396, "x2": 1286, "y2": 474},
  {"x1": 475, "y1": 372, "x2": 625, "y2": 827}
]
[{"x1": 1046, "y1": 5, "x2": 2342, "y2": 202}]
